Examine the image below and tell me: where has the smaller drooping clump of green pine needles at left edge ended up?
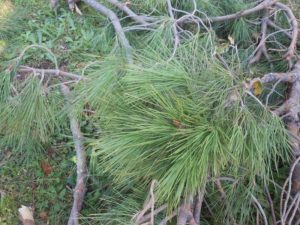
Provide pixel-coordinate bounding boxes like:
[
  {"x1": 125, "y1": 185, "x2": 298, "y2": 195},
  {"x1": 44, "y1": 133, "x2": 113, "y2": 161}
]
[{"x1": 0, "y1": 77, "x2": 63, "y2": 149}]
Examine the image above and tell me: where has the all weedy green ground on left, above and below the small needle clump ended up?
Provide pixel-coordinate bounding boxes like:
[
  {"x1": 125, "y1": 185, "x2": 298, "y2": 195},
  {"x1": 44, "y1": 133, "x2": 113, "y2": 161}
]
[{"x1": 0, "y1": 0, "x2": 103, "y2": 225}]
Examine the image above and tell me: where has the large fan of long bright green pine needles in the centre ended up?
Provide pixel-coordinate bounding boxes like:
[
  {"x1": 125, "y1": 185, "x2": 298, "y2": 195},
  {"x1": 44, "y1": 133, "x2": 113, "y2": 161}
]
[{"x1": 84, "y1": 34, "x2": 289, "y2": 217}]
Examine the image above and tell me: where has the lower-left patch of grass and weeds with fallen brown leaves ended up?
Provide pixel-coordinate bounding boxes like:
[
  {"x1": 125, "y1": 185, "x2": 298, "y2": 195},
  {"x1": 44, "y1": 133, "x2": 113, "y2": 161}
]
[{"x1": 0, "y1": 146, "x2": 75, "y2": 225}]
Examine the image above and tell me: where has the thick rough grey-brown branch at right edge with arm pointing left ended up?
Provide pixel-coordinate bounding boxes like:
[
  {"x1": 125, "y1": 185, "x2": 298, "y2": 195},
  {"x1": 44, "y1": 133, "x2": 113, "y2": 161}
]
[{"x1": 250, "y1": 61, "x2": 300, "y2": 221}]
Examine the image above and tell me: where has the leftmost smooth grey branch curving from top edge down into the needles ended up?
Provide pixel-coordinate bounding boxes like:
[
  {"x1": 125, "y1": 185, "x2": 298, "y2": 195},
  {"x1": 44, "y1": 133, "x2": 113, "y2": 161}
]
[{"x1": 82, "y1": 0, "x2": 132, "y2": 63}]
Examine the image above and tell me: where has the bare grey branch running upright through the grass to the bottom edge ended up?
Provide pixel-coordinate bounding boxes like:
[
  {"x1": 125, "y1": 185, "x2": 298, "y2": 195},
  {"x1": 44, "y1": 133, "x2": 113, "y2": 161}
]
[{"x1": 61, "y1": 84, "x2": 88, "y2": 225}]
